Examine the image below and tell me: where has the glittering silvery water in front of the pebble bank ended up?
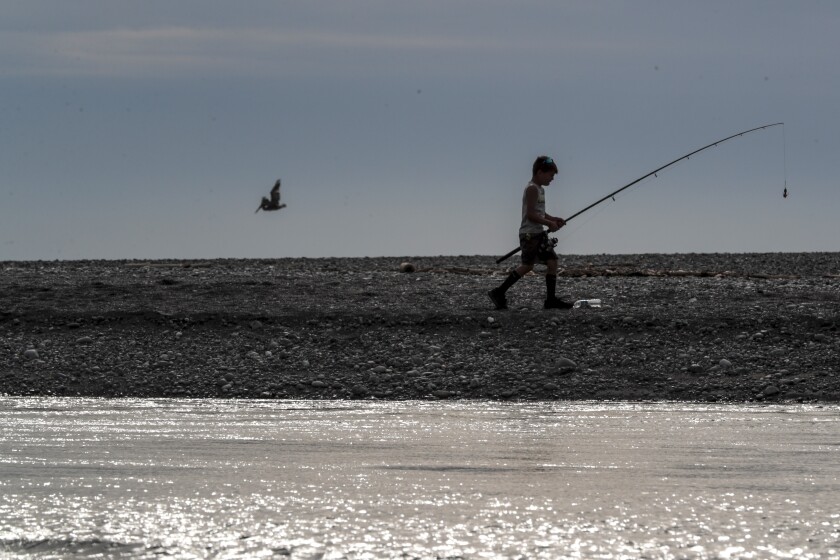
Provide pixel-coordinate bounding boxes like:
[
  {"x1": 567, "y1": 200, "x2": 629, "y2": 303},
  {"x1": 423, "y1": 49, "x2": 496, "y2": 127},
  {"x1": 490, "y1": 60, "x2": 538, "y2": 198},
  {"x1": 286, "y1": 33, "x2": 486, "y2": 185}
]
[{"x1": 0, "y1": 397, "x2": 840, "y2": 559}]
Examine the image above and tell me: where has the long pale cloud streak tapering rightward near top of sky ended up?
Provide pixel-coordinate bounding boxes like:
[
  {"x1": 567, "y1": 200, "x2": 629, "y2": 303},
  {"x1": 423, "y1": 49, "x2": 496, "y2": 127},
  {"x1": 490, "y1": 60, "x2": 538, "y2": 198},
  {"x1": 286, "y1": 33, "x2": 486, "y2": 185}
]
[{"x1": 0, "y1": 27, "x2": 520, "y2": 77}]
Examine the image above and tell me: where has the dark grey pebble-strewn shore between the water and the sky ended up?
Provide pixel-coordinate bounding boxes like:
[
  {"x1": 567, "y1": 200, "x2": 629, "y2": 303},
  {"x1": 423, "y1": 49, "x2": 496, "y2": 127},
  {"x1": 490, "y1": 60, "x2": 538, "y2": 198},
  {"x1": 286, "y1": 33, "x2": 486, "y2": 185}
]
[{"x1": 0, "y1": 253, "x2": 840, "y2": 402}]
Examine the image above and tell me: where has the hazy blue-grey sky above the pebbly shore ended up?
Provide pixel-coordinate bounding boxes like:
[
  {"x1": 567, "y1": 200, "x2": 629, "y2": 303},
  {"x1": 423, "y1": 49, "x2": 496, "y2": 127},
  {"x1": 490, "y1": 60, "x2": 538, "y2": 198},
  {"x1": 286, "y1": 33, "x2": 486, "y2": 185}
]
[{"x1": 0, "y1": 0, "x2": 840, "y2": 261}]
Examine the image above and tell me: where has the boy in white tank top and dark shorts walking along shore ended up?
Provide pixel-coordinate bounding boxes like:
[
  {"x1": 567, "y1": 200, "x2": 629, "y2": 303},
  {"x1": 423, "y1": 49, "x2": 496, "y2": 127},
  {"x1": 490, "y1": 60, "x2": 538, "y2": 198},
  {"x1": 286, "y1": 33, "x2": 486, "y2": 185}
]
[{"x1": 487, "y1": 156, "x2": 572, "y2": 309}]
